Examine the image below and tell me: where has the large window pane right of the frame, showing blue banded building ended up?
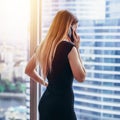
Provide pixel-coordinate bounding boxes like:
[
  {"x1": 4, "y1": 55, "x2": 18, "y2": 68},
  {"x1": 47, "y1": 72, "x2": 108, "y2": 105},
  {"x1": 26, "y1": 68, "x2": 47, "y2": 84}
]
[{"x1": 41, "y1": 0, "x2": 120, "y2": 120}]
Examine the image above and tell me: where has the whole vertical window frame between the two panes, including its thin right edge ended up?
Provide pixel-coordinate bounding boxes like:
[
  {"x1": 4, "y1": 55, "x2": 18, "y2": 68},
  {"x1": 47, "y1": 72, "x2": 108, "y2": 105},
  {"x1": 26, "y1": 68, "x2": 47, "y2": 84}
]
[{"x1": 29, "y1": 0, "x2": 42, "y2": 120}]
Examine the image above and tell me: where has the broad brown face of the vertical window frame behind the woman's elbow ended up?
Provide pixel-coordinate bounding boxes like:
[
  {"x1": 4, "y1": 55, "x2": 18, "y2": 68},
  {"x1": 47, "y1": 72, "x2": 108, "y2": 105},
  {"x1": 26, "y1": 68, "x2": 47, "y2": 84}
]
[{"x1": 29, "y1": 0, "x2": 39, "y2": 120}]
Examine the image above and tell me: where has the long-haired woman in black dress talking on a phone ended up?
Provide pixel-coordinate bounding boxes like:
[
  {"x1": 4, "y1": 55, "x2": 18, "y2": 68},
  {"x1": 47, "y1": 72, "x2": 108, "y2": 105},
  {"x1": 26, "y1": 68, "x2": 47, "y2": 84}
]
[{"x1": 25, "y1": 10, "x2": 86, "y2": 120}]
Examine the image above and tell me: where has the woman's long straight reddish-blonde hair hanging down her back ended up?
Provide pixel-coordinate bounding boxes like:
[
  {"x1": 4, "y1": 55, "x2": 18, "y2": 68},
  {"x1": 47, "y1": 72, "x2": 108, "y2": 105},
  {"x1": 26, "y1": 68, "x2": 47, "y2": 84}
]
[{"x1": 36, "y1": 10, "x2": 78, "y2": 79}]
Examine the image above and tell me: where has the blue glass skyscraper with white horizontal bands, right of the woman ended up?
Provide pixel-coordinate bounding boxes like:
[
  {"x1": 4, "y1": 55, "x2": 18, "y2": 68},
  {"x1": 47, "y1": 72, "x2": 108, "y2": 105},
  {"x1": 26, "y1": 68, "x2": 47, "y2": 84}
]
[{"x1": 74, "y1": 0, "x2": 120, "y2": 120}]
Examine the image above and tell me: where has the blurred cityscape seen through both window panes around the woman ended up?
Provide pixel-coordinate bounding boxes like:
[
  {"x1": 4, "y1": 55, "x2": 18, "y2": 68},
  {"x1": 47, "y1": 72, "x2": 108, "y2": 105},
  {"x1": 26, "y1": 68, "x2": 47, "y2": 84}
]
[{"x1": 0, "y1": 0, "x2": 120, "y2": 120}]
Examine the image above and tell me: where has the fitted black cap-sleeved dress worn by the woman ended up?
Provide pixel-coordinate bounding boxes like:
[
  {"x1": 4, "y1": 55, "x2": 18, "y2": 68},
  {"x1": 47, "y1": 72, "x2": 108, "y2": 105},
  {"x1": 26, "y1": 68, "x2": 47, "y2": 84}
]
[{"x1": 38, "y1": 41, "x2": 77, "y2": 120}]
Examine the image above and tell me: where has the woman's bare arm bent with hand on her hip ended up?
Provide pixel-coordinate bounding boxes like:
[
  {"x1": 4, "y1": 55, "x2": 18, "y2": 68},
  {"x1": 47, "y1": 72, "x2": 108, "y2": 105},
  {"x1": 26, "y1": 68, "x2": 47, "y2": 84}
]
[{"x1": 25, "y1": 54, "x2": 48, "y2": 86}]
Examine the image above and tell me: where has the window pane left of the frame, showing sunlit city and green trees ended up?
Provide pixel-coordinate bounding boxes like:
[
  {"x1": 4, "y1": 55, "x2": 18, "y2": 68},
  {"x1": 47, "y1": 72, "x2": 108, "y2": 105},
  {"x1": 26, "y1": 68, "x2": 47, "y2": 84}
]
[{"x1": 0, "y1": 0, "x2": 30, "y2": 120}]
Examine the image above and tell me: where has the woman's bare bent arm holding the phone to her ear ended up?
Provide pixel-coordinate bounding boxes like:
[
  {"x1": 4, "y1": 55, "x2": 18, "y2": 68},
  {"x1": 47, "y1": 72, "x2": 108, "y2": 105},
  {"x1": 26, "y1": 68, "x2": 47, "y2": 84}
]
[{"x1": 68, "y1": 24, "x2": 86, "y2": 82}]
